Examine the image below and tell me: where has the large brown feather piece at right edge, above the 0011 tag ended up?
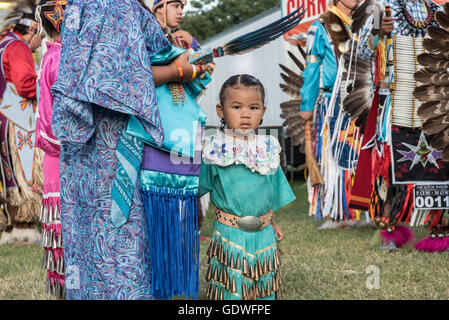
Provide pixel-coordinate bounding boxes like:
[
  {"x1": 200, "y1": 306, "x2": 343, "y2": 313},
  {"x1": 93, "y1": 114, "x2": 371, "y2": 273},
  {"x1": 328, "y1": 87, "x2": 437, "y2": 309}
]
[{"x1": 414, "y1": 3, "x2": 449, "y2": 161}]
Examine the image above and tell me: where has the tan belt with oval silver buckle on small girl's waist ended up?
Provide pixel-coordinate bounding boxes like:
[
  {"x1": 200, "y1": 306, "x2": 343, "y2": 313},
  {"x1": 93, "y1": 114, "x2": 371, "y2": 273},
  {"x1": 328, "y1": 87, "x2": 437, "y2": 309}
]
[{"x1": 215, "y1": 209, "x2": 273, "y2": 232}]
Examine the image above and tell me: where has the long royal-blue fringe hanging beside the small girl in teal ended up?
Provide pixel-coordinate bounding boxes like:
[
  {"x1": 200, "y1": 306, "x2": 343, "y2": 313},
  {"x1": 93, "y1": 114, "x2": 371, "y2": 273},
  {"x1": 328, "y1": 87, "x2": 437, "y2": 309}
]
[{"x1": 142, "y1": 186, "x2": 199, "y2": 299}]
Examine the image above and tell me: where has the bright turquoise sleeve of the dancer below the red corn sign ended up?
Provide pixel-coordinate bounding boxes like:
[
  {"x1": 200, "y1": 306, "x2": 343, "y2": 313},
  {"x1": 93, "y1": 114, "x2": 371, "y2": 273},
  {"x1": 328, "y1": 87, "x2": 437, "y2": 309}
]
[{"x1": 300, "y1": 21, "x2": 324, "y2": 111}]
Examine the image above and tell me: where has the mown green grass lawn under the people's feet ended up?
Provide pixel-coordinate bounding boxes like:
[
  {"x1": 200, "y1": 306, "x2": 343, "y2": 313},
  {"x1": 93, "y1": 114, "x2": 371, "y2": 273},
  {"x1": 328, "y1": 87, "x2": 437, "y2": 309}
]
[{"x1": 0, "y1": 181, "x2": 449, "y2": 300}]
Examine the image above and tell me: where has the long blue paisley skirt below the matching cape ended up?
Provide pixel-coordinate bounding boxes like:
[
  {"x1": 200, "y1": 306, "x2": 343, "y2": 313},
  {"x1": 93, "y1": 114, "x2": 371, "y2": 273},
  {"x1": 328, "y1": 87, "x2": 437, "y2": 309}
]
[{"x1": 60, "y1": 108, "x2": 152, "y2": 300}]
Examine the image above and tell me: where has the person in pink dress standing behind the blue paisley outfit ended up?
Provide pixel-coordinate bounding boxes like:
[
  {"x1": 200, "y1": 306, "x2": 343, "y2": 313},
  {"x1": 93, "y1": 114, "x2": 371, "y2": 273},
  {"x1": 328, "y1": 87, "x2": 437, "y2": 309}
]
[{"x1": 36, "y1": 0, "x2": 67, "y2": 299}]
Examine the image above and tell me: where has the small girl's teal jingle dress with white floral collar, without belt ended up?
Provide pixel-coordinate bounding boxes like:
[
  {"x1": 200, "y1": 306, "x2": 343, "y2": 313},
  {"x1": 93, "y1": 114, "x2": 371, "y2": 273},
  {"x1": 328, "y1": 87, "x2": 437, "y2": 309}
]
[{"x1": 200, "y1": 133, "x2": 295, "y2": 300}]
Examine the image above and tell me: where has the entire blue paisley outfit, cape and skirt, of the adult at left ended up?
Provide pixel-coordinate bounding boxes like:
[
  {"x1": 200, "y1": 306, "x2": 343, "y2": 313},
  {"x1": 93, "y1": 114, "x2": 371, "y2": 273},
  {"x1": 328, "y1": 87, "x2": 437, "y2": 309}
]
[{"x1": 52, "y1": 0, "x2": 170, "y2": 299}]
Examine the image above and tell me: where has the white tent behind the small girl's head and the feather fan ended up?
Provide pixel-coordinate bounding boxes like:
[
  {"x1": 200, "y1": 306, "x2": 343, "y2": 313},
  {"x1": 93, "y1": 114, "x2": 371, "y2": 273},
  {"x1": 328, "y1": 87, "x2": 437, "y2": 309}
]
[{"x1": 199, "y1": 7, "x2": 299, "y2": 127}]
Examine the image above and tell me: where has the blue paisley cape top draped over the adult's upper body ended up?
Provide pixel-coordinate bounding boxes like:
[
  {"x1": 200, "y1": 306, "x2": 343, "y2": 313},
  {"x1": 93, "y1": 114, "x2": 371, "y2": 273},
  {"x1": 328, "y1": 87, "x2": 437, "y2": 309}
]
[{"x1": 52, "y1": 0, "x2": 170, "y2": 142}]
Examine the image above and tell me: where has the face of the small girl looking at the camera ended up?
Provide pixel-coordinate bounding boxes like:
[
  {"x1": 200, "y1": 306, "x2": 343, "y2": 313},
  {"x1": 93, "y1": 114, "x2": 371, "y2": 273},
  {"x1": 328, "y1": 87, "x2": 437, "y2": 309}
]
[{"x1": 217, "y1": 86, "x2": 266, "y2": 131}]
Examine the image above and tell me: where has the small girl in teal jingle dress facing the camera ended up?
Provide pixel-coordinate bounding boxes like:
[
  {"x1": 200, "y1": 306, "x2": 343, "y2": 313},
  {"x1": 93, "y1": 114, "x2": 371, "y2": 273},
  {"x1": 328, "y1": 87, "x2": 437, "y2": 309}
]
[{"x1": 200, "y1": 75, "x2": 295, "y2": 300}]
